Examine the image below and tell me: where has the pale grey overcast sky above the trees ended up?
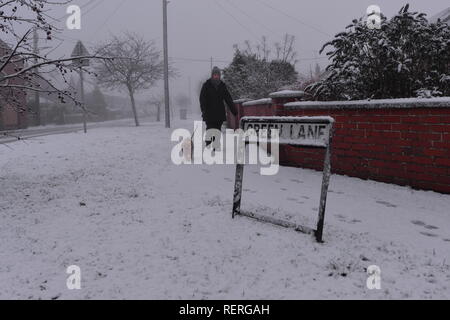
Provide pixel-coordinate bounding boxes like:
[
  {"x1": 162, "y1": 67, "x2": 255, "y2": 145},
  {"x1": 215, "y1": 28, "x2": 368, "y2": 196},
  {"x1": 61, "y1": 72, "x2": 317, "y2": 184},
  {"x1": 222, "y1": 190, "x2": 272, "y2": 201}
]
[{"x1": 47, "y1": 0, "x2": 449, "y2": 101}]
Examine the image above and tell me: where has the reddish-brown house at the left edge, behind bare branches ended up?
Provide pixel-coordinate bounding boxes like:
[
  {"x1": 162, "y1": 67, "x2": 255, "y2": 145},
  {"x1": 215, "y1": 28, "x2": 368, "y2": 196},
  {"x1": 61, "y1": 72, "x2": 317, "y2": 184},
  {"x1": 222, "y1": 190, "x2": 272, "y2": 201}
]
[{"x1": 0, "y1": 39, "x2": 27, "y2": 131}]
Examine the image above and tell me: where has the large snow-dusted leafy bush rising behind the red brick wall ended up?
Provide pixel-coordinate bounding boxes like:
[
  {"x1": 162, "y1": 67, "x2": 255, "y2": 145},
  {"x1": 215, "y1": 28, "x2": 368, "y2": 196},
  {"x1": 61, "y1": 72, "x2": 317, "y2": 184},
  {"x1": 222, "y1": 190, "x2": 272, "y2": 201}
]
[{"x1": 307, "y1": 6, "x2": 450, "y2": 100}]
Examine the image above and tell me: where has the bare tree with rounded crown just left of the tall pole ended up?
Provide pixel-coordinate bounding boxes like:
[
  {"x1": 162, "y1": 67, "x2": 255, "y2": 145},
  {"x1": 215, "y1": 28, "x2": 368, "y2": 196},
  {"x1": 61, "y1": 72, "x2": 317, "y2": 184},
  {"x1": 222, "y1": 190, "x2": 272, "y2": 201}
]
[{"x1": 95, "y1": 32, "x2": 164, "y2": 126}]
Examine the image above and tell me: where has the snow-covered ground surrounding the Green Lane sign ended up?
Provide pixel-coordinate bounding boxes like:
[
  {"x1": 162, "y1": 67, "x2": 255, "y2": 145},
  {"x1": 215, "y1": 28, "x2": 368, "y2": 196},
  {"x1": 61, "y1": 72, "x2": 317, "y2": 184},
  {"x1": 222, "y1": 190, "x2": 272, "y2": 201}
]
[{"x1": 0, "y1": 121, "x2": 450, "y2": 299}]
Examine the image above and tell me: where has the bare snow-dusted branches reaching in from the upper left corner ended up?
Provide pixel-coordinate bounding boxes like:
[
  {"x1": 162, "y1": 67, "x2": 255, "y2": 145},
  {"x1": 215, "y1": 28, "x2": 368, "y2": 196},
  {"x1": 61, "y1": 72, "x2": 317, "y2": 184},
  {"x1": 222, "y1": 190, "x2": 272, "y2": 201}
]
[{"x1": 0, "y1": 0, "x2": 109, "y2": 111}]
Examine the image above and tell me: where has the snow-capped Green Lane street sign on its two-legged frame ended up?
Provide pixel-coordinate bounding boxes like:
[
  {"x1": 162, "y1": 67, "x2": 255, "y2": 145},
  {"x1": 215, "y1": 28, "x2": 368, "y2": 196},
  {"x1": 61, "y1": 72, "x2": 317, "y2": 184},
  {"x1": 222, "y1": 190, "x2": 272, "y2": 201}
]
[{"x1": 232, "y1": 117, "x2": 334, "y2": 242}]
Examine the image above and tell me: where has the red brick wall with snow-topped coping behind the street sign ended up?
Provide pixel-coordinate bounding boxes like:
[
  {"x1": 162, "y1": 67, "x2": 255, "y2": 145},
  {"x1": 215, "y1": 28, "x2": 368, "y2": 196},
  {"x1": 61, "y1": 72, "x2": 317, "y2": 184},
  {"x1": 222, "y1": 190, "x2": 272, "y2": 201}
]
[{"x1": 232, "y1": 98, "x2": 450, "y2": 193}]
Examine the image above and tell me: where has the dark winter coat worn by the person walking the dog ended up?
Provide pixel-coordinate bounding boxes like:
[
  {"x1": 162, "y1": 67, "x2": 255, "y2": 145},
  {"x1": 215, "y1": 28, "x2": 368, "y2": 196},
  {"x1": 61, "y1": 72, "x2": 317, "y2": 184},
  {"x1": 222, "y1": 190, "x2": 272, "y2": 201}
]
[{"x1": 200, "y1": 79, "x2": 237, "y2": 123}]
